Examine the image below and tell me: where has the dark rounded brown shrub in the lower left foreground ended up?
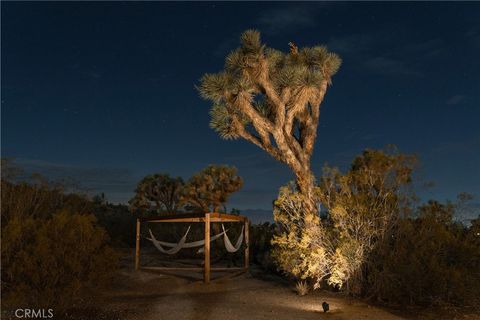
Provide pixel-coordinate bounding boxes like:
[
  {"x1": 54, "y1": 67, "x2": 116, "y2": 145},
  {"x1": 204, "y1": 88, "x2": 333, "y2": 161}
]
[{"x1": 2, "y1": 211, "x2": 117, "y2": 310}]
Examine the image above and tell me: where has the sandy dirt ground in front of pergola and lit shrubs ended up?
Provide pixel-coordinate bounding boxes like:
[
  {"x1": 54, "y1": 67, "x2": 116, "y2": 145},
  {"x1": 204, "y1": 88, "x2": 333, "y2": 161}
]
[{"x1": 95, "y1": 252, "x2": 480, "y2": 320}]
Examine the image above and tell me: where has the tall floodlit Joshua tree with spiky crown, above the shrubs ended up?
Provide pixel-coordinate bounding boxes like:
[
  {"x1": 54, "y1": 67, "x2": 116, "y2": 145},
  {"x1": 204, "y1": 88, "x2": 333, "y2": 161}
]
[{"x1": 199, "y1": 30, "x2": 341, "y2": 218}]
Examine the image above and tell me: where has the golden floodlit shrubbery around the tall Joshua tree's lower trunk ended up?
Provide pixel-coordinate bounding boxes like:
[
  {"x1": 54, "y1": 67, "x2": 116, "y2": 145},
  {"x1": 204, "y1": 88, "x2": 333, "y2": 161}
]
[{"x1": 273, "y1": 150, "x2": 414, "y2": 294}]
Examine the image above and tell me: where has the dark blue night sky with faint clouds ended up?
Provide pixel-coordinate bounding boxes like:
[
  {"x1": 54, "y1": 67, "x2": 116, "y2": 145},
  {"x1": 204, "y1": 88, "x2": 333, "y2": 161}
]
[{"x1": 1, "y1": 2, "x2": 480, "y2": 209}]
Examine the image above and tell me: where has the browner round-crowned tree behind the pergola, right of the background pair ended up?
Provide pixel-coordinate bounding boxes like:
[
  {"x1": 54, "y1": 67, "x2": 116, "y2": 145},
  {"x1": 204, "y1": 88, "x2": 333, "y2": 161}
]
[{"x1": 182, "y1": 165, "x2": 243, "y2": 212}]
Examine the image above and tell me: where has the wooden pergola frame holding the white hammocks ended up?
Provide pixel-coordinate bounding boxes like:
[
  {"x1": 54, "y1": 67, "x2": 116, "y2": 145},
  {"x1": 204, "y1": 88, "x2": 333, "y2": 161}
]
[{"x1": 135, "y1": 212, "x2": 249, "y2": 283}]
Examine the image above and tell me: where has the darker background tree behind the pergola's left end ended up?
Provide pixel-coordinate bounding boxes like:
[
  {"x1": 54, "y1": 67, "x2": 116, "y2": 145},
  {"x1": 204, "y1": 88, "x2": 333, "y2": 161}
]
[{"x1": 128, "y1": 174, "x2": 184, "y2": 213}]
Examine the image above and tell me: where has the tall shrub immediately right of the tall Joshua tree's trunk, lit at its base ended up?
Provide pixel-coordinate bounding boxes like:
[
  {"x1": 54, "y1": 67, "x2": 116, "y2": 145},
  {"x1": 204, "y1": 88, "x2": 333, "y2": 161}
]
[{"x1": 318, "y1": 149, "x2": 415, "y2": 295}]
